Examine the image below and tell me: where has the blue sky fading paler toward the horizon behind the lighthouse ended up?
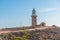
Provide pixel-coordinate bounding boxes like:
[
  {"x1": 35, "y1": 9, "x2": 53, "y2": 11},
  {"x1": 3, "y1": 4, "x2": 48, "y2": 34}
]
[{"x1": 0, "y1": 0, "x2": 60, "y2": 28}]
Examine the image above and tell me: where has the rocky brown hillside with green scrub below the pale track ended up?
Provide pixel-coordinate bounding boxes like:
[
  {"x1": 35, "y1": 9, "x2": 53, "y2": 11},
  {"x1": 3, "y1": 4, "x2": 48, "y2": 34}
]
[{"x1": 0, "y1": 27, "x2": 60, "y2": 40}]
